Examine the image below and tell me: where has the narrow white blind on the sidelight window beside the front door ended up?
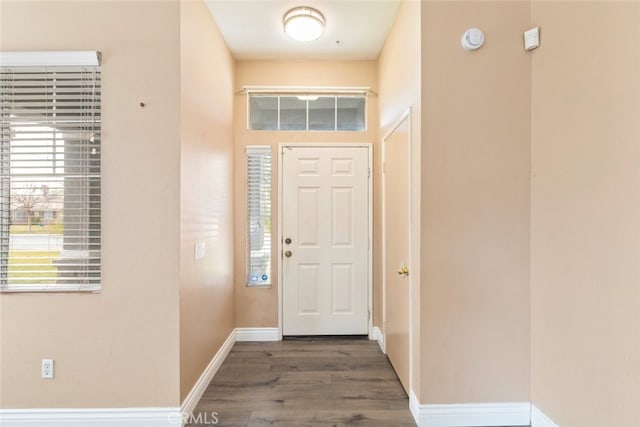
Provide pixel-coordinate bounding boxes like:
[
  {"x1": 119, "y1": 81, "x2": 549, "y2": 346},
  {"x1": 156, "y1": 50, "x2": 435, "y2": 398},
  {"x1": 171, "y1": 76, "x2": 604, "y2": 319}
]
[{"x1": 247, "y1": 146, "x2": 271, "y2": 286}]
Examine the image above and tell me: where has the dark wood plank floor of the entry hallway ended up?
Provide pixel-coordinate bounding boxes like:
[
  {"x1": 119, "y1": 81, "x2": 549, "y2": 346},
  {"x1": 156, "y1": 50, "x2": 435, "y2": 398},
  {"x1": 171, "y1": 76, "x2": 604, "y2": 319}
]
[{"x1": 189, "y1": 339, "x2": 415, "y2": 427}]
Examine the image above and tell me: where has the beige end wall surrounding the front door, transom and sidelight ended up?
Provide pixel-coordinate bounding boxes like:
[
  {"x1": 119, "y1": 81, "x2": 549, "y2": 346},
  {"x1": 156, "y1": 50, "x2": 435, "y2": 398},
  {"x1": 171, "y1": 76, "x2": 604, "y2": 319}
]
[{"x1": 234, "y1": 61, "x2": 378, "y2": 327}]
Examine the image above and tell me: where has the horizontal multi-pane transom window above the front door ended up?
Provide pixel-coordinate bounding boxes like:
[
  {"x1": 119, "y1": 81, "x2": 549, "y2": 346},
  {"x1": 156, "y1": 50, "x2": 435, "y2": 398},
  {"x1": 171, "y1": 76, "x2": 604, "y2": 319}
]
[{"x1": 248, "y1": 93, "x2": 366, "y2": 131}]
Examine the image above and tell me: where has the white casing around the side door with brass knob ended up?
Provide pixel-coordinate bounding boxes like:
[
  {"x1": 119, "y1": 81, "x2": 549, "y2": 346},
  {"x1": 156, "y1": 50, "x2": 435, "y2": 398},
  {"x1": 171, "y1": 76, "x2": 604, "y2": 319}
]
[{"x1": 380, "y1": 107, "x2": 413, "y2": 392}]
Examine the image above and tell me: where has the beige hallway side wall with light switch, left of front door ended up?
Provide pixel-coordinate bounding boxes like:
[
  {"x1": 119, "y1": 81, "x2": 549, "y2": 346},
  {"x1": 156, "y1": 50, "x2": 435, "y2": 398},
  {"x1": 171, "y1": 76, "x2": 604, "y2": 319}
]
[{"x1": 180, "y1": 1, "x2": 235, "y2": 400}]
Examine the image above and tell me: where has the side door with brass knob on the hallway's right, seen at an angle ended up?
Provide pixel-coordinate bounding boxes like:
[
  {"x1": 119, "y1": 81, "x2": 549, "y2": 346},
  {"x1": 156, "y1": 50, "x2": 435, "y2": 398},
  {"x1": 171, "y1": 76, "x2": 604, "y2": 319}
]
[{"x1": 383, "y1": 116, "x2": 411, "y2": 391}]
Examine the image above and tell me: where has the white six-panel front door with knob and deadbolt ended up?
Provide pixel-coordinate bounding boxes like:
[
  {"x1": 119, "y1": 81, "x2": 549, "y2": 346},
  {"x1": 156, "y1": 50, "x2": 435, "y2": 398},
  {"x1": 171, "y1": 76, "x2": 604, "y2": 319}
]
[{"x1": 280, "y1": 146, "x2": 370, "y2": 335}]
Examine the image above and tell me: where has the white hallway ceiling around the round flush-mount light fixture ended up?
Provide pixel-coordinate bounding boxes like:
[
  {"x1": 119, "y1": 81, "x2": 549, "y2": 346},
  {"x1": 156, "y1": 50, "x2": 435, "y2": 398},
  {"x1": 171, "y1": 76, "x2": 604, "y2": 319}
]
[{"x1": 206, "y1": 0, "x2": 399, "y2": 60}]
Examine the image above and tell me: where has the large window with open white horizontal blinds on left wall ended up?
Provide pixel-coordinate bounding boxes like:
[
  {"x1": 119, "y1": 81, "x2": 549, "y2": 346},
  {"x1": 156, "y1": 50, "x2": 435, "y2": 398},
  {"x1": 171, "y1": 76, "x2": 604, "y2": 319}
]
[{"x1": 0, "y1": 52, "x2": 101, "y2": 291}]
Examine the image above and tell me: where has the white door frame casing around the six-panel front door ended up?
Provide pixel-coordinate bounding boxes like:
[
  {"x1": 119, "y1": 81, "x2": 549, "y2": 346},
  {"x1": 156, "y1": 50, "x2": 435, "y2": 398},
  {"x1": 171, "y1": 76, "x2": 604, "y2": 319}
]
[{"x1": 276, "y1": 142, "x2": 373, "y2": 340}]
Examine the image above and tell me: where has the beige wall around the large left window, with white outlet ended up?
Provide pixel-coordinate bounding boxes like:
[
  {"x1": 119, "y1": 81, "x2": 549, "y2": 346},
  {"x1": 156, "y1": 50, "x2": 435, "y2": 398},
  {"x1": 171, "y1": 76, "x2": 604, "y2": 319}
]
[{"x1": 0, "y1": 1, "x2": 180, "y2": 408}]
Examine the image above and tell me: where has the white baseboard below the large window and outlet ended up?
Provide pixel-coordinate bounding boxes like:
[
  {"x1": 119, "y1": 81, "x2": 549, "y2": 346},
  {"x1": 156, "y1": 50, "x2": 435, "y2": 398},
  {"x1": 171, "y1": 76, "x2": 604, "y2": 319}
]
[{"x1": 0, "y1": 407, "x2": 182, "y2": 427}]
